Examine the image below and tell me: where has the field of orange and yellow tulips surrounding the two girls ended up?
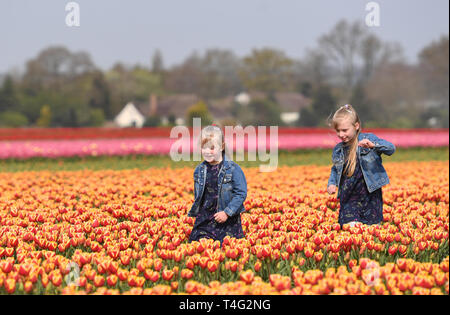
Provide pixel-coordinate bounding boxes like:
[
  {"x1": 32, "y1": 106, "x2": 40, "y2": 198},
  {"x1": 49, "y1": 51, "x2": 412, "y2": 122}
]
[{"x1": 0, "y1": 130, "x2": 449, "y2": 295}]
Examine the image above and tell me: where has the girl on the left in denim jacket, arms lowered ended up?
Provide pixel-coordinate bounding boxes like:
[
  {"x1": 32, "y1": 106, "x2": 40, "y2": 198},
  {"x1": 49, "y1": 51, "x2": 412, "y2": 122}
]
[{"x1": 188, "y1": 126, "x2": 247, "y2": 243}]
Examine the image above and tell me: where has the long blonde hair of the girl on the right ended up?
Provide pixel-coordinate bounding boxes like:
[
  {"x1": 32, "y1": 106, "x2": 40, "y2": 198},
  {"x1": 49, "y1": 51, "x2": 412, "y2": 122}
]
[{"x1": 329, "y1": 104, "x2": 361, "y2": 177}]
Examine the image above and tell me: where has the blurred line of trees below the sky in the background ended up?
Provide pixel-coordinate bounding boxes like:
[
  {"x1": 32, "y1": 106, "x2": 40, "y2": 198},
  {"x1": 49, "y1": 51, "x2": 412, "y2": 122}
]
[{"x1": 0, "y1": 20, "x2": 449, "y2": 128}]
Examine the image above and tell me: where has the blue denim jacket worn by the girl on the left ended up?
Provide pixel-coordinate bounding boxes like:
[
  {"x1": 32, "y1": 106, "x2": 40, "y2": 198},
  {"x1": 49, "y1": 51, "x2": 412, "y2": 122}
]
[{"x1": 188, "y1": 153, "x2": 247, "y2": 217}]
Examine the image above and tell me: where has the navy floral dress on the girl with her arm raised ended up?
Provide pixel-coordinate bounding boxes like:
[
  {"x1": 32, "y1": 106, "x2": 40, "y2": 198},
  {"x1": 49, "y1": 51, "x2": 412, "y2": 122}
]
[{"x1": 339, "y1": 147, "x2": 383, "y2": 226}]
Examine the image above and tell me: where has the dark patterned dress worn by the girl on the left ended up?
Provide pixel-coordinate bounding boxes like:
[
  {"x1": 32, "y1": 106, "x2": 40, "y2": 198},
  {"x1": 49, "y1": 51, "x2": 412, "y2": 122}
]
[{"x1": 189, "y1": 161, "x2": 244, "y2": 243}]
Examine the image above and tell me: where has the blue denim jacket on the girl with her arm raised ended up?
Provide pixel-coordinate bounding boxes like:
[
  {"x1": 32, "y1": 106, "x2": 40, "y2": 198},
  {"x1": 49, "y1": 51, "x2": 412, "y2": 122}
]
[{"x1": 328, "y1": 133, "x2": 395, "y2": 197}]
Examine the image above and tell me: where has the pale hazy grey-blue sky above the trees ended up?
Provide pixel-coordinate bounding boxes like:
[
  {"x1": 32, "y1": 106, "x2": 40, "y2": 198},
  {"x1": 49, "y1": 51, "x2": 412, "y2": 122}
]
[{"x1": 0, "y1": 0, "x2": 449, "y2": 73}]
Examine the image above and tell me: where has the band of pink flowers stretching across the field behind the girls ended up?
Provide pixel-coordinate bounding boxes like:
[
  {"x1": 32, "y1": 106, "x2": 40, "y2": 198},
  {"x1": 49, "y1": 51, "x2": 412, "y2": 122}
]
[{"x1": 0, "y1": 130, "x2": 449, "y2": 159}]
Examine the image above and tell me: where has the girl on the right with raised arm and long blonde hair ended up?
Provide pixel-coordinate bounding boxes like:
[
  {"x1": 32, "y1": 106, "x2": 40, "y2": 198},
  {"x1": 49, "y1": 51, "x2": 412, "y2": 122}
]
[{"x1": 327, "y1": 105, "x2": 395, "y2": 226}]
